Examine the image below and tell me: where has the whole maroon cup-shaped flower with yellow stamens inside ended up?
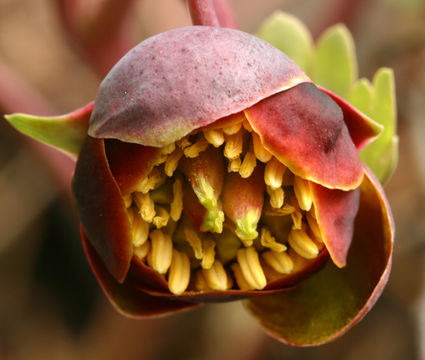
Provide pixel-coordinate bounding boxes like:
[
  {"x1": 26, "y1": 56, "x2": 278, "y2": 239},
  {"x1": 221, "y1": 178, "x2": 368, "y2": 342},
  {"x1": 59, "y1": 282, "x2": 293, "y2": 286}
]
[{"x1": 68, "y1": 27, "x2": 393, "y2": 345}]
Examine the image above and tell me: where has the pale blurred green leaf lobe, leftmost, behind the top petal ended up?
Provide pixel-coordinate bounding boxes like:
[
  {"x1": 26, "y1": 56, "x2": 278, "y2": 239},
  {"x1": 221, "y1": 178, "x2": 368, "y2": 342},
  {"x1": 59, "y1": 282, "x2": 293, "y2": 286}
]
[{"x1": 257, "y1": 11, "x2": 313, "y2": 74}]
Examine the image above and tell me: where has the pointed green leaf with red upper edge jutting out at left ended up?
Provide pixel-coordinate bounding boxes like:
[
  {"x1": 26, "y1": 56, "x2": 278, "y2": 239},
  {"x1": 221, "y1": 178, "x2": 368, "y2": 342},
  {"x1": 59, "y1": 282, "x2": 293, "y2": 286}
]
[{"x1": 5, "y1": 102, "x2": 94, "y2": 158}]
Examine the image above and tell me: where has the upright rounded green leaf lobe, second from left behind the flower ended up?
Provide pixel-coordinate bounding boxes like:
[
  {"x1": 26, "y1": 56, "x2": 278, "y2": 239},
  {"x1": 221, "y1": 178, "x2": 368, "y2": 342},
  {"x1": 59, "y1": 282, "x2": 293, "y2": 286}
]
[{"x1": 313, "y1": 24, "x2": 357, "y2": 99}]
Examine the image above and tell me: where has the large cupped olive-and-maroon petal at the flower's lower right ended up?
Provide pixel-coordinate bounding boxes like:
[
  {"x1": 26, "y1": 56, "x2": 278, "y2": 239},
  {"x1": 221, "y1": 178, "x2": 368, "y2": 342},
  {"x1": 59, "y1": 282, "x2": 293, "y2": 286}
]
[{"x1": 246, "y1": 170, "x2": 394, "y2": 346}]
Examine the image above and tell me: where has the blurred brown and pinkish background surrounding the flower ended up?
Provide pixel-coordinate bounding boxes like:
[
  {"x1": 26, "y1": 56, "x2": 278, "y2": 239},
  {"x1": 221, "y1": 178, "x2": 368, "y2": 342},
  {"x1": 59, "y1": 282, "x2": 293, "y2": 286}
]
[{"x1": 0, "y1": 0, "x2": 425, "y2": 360}]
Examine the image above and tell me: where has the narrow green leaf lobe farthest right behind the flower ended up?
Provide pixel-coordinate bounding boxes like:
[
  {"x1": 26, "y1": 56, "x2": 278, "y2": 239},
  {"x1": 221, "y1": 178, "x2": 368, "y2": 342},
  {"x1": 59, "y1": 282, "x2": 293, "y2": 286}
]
[{"x1": 360, "y1": 68, "x2": 398, "y2": 183}]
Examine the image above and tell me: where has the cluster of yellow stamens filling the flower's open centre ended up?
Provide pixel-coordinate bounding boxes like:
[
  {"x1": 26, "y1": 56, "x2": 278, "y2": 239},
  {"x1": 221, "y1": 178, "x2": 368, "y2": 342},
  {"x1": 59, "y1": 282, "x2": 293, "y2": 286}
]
[{"x1": 124, "y1": 115, "x2": 323, "y2": 295}]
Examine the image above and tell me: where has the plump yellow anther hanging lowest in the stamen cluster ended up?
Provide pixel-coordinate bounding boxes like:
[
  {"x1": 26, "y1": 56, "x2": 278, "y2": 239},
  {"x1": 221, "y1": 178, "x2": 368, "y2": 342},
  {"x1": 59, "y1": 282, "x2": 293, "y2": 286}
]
[{"x1": 168, "y1": 250, "x2": 190, "y2": 295}]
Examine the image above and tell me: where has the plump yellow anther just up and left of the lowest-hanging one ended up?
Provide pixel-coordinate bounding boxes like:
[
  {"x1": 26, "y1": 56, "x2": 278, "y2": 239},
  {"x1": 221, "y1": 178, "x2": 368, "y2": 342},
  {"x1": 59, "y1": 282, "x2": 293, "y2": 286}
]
[{"x1": 148, "y1": 230, "x2": 173, "y2": 274}]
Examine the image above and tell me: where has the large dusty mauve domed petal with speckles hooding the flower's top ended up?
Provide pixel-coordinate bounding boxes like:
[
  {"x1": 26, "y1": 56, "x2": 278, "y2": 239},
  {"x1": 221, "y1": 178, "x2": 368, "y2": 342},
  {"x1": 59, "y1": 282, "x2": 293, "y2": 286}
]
[{"x1": 89, "y1": 26, "x2": 310, "y2": 146}]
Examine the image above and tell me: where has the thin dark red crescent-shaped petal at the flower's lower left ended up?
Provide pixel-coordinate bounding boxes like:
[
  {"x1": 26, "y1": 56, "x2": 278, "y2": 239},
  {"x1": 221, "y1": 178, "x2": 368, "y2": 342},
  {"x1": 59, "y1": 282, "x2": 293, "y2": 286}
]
[{"x1": 81, "y1": 231, "x2": 199, "y2": 318}]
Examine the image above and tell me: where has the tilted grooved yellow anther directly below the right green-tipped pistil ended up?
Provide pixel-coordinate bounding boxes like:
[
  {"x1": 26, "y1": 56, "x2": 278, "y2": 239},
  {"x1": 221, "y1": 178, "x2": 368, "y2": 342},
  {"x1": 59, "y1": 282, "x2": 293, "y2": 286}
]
[{"x1": 237, "y1": 247, "x2": 267, "y2": 290}]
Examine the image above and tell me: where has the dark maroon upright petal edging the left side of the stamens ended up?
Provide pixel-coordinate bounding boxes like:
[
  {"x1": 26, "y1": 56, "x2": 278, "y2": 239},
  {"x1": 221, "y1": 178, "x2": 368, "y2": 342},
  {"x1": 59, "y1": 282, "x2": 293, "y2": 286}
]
[{"x1": 72, "y1": 137, "x2": 132, "y2": 282}]
